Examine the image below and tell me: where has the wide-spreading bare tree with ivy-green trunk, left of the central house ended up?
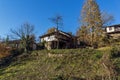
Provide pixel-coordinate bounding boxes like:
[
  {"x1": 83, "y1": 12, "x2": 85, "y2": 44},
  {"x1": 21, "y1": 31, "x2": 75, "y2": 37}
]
[{"x1": 11, "y1": 23, "x2": 35, "y2": 52}]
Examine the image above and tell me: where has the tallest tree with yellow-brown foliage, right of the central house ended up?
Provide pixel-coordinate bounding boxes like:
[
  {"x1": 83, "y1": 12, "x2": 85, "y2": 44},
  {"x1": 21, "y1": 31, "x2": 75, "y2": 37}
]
[{"x1": 81, "y1": 0, "x2": 103, "y2": 47}]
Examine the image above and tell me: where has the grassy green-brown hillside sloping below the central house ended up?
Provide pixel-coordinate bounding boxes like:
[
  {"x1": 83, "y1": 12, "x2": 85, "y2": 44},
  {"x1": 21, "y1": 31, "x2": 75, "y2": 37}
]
[{"x1": 0, "y1": 49, "x2": 120, "y2": 80}]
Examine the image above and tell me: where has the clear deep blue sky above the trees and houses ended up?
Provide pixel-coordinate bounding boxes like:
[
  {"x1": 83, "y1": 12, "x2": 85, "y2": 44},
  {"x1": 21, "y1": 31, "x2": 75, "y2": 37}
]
[{"x1": 0, "y1": 0, "x2": 120, "y2": 37}]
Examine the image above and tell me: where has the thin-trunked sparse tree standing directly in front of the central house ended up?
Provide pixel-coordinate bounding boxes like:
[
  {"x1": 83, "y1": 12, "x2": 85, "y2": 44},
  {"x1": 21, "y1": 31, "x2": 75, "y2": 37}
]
[{"x1": 49, "y1": 15, "x2": 63, "y2": 49}]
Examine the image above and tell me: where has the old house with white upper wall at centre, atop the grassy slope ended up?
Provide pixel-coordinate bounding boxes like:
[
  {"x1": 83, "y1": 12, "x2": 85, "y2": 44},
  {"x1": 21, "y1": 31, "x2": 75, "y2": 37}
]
[{"x1": 40, "y1": 30, "x2": 77, "y2": 49}]
